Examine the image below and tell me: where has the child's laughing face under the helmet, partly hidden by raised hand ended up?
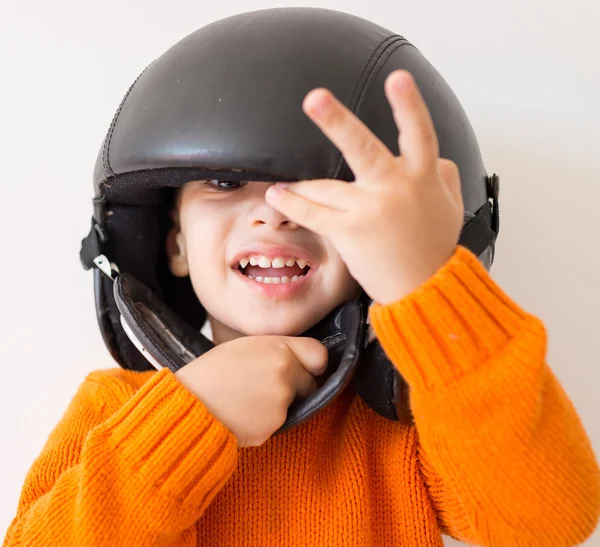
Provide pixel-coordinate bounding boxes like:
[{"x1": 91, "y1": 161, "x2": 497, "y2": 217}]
[{"x1": 167, "y1": 180, "x2": 360, "y2": 343}]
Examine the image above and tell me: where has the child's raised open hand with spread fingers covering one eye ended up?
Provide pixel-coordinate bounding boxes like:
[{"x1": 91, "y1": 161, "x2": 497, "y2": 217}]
[{"x1": 266, "y1": 70, "x2": 464, "y2": 304}]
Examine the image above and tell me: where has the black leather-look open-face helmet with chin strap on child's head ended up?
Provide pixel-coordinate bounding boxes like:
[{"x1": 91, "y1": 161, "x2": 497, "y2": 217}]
[{"x1": 81, "y1": 8, "x2": 498, "y2": 431}]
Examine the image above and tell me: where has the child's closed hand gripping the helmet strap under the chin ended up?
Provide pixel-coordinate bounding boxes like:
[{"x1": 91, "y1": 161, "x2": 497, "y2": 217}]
[{"x1": 175, "y1": 336, "x2": 328, "y2": 447}]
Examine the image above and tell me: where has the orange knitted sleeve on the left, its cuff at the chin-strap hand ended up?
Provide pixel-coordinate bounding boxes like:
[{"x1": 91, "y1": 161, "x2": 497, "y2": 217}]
[{"x1": 4, "y1": 369, "x2": 237, "y2": 547}]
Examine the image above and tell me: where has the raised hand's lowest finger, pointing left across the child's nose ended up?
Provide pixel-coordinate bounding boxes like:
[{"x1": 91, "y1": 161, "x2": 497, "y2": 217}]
[{"x1": 265, "y1": 184, "x2": 339, "y2": 235}]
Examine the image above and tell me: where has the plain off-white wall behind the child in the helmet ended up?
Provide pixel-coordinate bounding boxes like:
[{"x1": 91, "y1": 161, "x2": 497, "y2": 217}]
[{"x1": 0, "y1": 0, "x2": 600, "y2": 546}]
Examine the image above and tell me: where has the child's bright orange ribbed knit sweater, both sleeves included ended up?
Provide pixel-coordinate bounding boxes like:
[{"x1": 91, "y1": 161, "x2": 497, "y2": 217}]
[{"x1": 4, "y1": 247, "x2": 600, "y2": 547}]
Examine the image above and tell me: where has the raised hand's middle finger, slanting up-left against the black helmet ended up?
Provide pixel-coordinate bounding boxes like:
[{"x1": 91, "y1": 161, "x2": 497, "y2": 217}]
[{"x1": 302, "y1": 88, "x2": 394, "y2": 183}]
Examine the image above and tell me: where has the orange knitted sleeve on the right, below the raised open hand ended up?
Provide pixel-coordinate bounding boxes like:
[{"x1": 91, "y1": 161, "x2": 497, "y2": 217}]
[{"x1": 370, "y1": 247, "x2": 600, "y2": 547}]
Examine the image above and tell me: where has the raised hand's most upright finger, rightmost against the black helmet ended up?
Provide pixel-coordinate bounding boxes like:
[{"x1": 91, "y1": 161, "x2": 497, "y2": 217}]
[{"x1": 385, "y1": 70, "x2": 440, "y2": 172}]
